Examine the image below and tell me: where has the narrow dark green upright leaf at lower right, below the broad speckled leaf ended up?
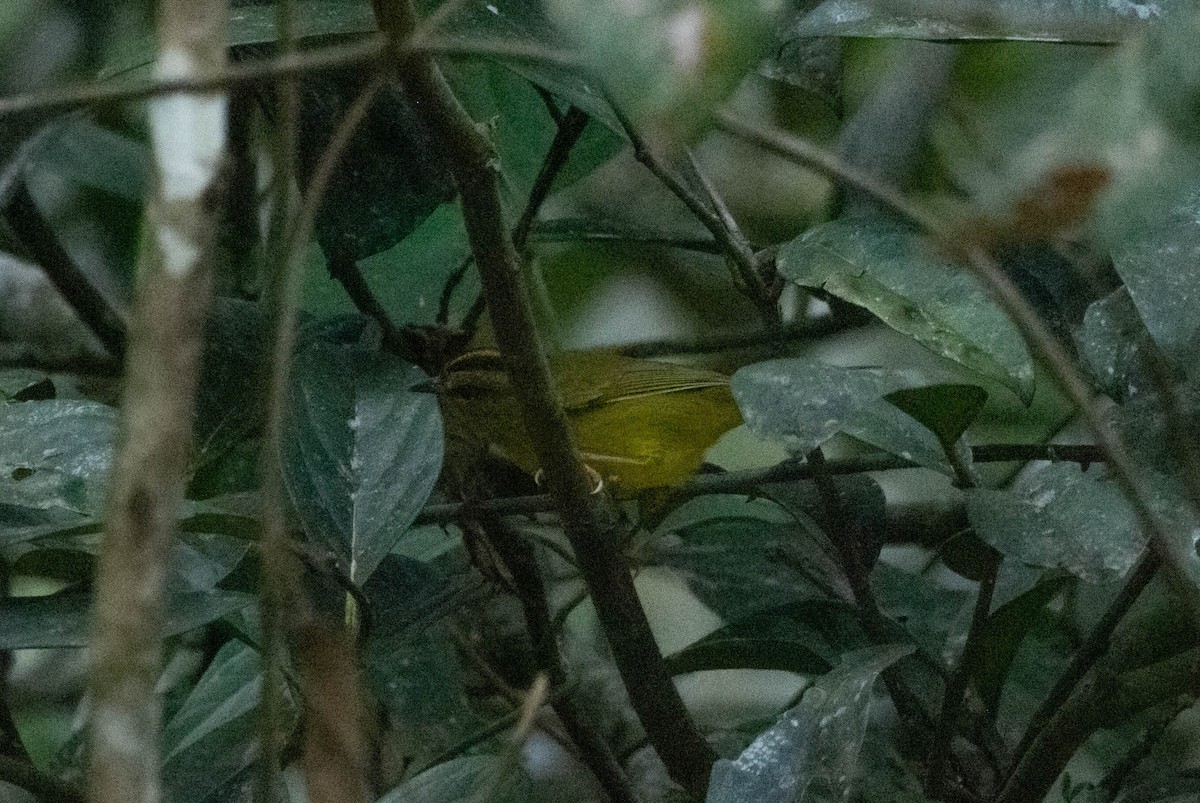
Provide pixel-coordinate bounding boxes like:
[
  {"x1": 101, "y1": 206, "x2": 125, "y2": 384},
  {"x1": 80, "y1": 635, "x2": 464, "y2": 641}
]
[{"x1": 970, "y1": 575, "x2": 1070, "y2": 711}]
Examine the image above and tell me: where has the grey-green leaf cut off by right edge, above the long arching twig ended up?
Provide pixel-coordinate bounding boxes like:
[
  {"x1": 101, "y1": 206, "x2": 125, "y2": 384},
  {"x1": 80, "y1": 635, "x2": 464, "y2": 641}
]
[{"x1": 1102, "y1": 190, "x2": 1200, "y2": 373}]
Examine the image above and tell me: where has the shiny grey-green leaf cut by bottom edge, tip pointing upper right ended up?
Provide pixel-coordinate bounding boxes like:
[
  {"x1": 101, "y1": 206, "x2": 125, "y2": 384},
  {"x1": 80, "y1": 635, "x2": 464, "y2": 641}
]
[{"x1": 707, "y1": 646, "x2": 913, "y2": 803}]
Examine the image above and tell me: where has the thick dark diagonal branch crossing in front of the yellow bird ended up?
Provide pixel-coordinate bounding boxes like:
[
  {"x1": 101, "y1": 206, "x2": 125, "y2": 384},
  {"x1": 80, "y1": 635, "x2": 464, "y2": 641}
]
[{"x1": 376, "y1": 0, "x2": 716, "y2": 798}]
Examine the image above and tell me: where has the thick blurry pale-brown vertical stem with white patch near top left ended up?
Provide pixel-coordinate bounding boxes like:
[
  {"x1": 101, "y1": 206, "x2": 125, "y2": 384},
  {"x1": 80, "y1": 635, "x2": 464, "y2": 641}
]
[{"x1": 89, "y1": 0, "x2": 228, "y2": 803}]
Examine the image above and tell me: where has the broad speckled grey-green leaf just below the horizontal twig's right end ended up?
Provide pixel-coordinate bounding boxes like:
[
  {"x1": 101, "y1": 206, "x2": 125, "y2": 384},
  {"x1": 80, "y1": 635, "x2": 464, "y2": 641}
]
[{"x1": 967, "y1": 463, "x2": 1145, "y2": 582}]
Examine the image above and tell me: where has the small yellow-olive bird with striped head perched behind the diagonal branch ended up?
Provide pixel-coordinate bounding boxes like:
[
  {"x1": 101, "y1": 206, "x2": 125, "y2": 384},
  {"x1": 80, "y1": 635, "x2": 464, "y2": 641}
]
[{"x1": 436, "y1": 349, "x2": 742, "y2": 491}]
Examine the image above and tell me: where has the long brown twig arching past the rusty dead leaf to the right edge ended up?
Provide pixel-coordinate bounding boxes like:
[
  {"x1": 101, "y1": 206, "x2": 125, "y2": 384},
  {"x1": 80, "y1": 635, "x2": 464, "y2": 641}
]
[{"x1": 719, "y1": 113, "x2": 1200, "y2": 627}]
